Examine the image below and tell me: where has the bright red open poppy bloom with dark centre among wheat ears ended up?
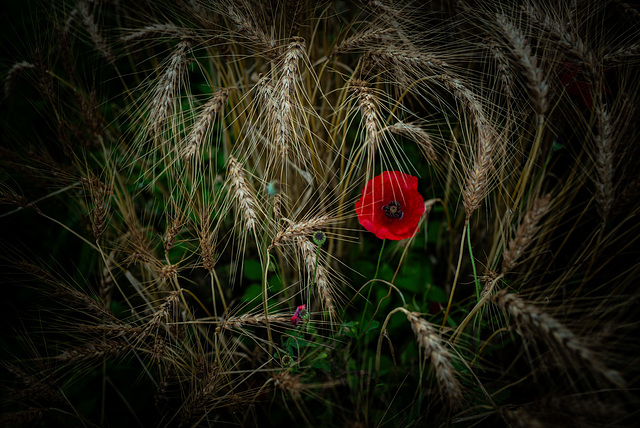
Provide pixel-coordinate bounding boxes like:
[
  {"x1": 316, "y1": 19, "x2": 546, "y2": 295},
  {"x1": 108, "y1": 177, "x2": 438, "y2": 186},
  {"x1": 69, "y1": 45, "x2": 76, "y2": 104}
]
[{"x1": 356, "y1": 171, "x2": 424, "y2": 241}]
